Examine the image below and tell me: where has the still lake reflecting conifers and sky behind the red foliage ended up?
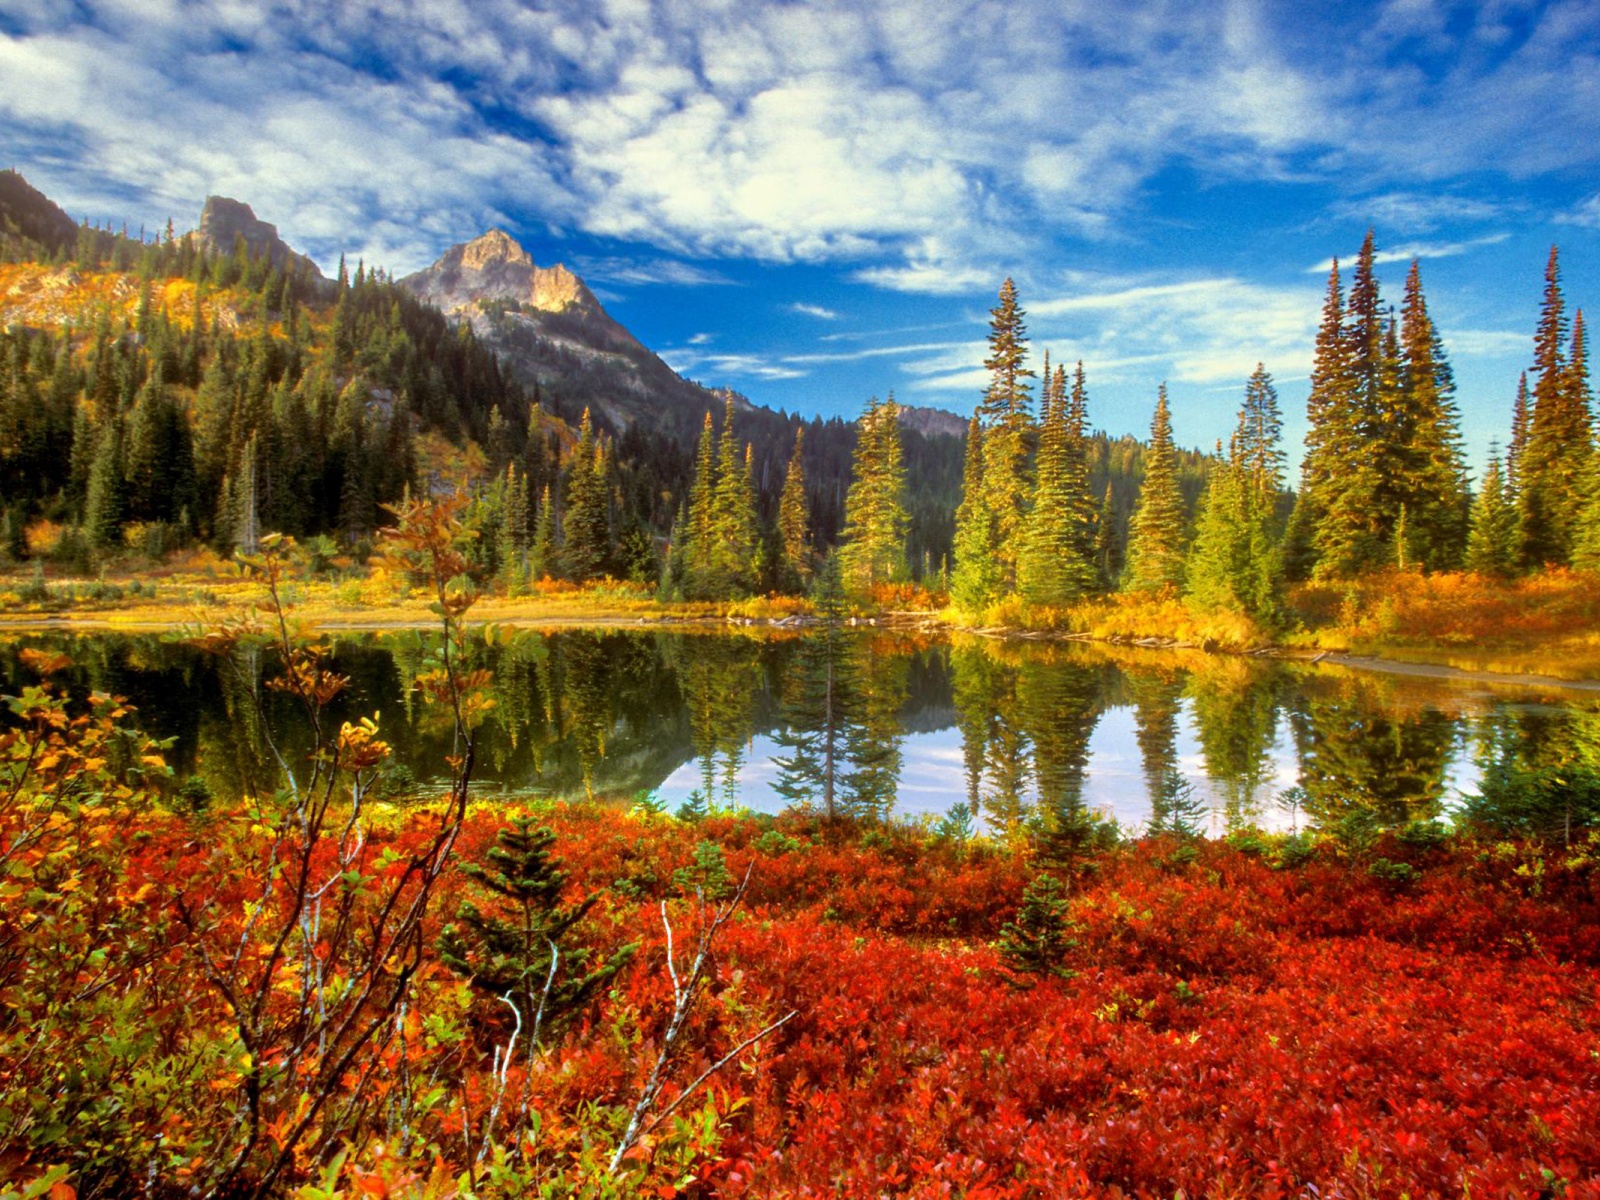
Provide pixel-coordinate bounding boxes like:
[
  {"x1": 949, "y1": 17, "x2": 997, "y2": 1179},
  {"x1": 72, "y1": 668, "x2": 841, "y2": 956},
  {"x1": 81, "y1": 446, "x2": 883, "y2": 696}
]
[{"x1": 0, "y1": 629, "x2": 1600, "y2": 834}]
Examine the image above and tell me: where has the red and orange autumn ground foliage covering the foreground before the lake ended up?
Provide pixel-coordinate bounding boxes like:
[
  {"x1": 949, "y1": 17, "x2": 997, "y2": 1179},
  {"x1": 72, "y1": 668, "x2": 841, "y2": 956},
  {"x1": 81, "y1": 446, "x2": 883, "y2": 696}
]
[{"x1": 0, "y1": 774, "x2": 1600, "y2": 1198}]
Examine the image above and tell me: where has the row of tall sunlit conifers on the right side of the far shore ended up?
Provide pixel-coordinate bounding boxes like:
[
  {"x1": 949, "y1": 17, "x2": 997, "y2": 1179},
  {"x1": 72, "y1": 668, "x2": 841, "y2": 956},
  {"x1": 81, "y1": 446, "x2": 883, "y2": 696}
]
[{"x1": 950, "y1": 232, "x2": 1600, "y2": 627}]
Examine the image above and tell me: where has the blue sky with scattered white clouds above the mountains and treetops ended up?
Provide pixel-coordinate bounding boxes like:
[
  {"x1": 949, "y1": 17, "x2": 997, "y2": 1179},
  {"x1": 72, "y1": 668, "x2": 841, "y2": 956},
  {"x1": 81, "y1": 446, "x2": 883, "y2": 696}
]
[{"x1": 0, "y1": 0, "x2": 1600, "y2": 466}]
